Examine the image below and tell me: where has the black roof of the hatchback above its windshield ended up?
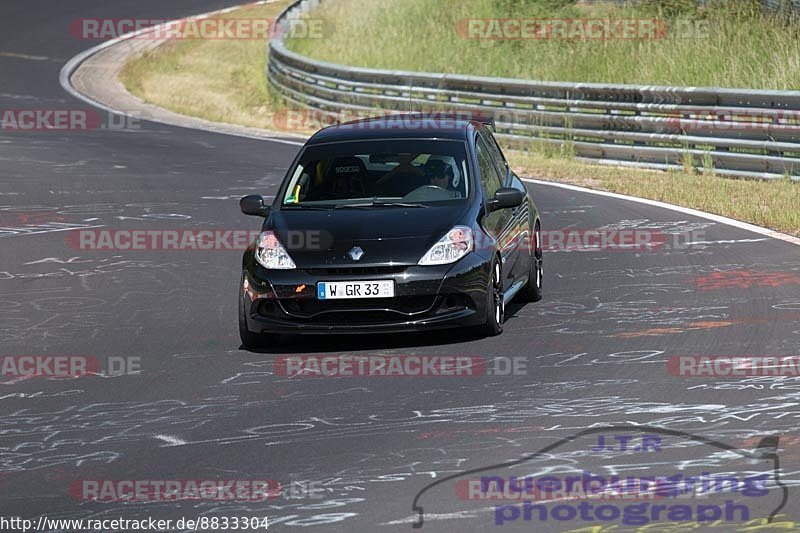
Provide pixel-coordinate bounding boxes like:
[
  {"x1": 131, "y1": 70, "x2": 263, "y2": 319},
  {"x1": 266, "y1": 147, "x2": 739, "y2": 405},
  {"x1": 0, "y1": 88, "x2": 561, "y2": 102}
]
[{"x1": 306, "y1": 113, "x2": 483, "y2": 145}]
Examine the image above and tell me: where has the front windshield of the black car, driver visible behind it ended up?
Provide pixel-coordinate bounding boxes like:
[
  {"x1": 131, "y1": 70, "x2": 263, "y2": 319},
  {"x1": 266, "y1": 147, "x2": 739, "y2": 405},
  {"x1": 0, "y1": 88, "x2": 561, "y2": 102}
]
[{"x1": 282, "y1": 140, "x2": 470, "y2": 208}]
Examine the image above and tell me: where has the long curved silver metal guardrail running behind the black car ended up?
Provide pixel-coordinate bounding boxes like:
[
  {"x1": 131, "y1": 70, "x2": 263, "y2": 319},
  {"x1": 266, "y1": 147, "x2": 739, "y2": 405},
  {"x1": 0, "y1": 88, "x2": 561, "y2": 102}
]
[{"x1": 267, "y1": 0, "x2": 800, "y2": 181}]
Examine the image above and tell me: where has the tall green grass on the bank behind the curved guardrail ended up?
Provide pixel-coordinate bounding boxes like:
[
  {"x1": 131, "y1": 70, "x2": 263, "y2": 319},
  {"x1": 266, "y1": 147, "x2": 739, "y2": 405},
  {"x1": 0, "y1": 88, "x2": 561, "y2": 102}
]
[{"x1": 287, "y1": 0, "x2": 800, "y2": 89}]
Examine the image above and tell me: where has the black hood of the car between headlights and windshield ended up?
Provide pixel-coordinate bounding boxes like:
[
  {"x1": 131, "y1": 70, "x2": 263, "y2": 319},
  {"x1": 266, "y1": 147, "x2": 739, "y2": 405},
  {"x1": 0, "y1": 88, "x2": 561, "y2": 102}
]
[{"x1": 264, "y1": 202, "x2": 469, "y2": 268}]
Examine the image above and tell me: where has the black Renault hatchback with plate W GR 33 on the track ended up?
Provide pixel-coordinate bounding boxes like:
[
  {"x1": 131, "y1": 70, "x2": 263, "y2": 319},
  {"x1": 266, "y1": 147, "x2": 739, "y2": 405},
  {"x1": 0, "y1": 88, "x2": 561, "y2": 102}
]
[{"x1": 239, "y1": 115, "x2": 542, "y2": 347}]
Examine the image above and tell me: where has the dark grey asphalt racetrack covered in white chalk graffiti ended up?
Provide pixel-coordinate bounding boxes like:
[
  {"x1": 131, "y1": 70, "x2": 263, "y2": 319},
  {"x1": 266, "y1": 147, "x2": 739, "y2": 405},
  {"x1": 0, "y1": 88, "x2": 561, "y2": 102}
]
[{"x1": 0, "y1": 0, "x2": 800, "y2": 532}]
